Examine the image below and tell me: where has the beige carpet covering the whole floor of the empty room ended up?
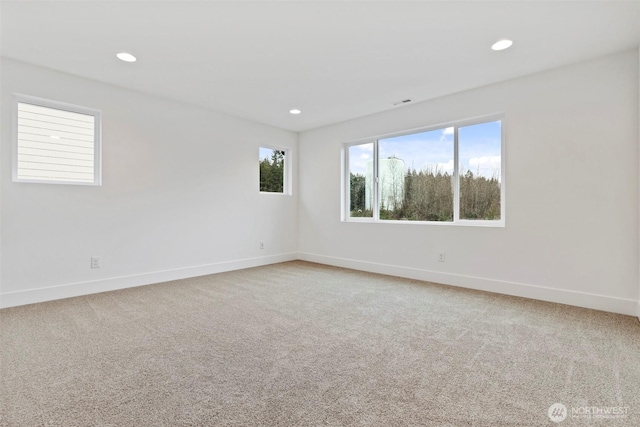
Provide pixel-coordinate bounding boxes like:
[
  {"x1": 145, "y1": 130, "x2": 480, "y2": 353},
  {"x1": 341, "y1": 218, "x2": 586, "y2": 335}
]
[{"x1": 0, "y1": 261, "x2": 640, "y2": 427}]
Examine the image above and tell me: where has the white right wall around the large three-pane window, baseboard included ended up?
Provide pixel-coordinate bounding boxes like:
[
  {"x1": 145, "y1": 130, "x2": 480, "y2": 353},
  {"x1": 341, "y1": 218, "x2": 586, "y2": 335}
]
[{"x1": 299, "y1": 50, "x2": 639, "y2": 314}]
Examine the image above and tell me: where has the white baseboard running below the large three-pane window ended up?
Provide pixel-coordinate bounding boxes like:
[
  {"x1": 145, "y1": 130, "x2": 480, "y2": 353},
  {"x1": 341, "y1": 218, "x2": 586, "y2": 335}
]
[{"x1": 298, "y1": 253, "x2": 640, "y2": 318}]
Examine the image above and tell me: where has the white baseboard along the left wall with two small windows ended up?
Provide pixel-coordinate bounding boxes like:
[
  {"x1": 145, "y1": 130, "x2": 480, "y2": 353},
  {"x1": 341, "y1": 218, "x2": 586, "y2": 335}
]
[{"x1": 0, "y1": 253, "x2": 298, "y2": 308}]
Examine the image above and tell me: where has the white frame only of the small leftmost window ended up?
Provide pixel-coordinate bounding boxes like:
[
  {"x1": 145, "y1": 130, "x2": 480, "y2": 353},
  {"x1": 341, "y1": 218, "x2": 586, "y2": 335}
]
[{"x1": 11, "y1": 93, "x2": 102, "y2": 186}]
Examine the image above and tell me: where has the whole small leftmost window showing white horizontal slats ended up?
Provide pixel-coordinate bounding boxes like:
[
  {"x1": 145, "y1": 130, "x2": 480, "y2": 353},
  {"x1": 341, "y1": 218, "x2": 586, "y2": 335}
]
[{"x1": 13, "y1": 95, "x2": 100, "y2": 185}]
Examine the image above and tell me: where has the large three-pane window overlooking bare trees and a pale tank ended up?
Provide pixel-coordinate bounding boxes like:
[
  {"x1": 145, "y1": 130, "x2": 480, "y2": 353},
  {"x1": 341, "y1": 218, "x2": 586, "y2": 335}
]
[{"x1": 344, "y1": 118, "x2": 504, "y2": 225}]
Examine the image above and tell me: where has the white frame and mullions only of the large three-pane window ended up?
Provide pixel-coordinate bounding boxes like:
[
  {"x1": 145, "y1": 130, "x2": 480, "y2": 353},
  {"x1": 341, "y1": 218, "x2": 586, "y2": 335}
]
[{"x1": 340, "y1": 113, "x2": 506, "y2": 227}]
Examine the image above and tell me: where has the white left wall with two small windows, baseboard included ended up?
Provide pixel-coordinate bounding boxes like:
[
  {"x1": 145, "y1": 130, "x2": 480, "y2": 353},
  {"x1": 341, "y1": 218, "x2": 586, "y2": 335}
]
[{"x1": 0, "y1": 59, "x2": 297, "y2": 306}]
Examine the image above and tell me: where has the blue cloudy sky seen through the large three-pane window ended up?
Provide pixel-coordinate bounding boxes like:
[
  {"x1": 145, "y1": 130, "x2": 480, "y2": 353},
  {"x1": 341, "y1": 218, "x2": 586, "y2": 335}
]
[{"x1": 349, "y1": 121, "x2": 501, "y2": 178}]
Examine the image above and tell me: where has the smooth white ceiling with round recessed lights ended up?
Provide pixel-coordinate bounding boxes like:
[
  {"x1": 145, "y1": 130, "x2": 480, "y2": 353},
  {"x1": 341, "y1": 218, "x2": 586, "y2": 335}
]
[{"x1": 0, "y1": 0, "x2": 640, "y2": 131}]
